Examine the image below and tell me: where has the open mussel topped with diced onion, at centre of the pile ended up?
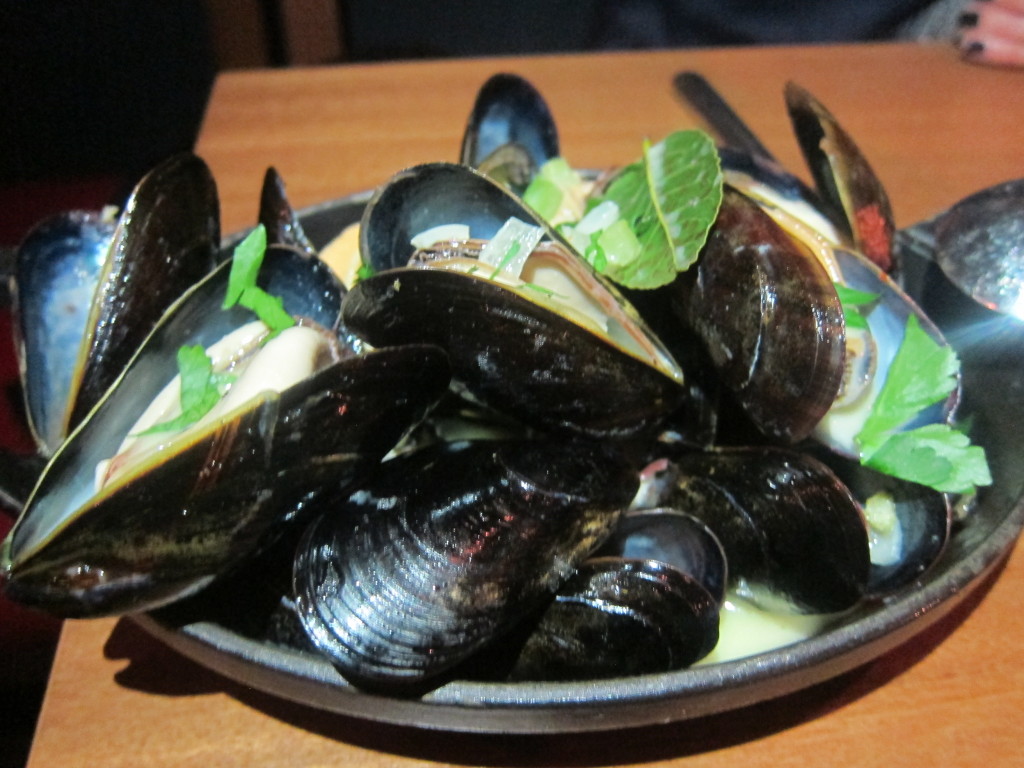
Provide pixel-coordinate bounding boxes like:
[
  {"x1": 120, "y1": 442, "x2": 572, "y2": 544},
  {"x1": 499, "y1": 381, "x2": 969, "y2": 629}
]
[{"x1": 342, "y1": 163, "x2": 684, "y2": 436}]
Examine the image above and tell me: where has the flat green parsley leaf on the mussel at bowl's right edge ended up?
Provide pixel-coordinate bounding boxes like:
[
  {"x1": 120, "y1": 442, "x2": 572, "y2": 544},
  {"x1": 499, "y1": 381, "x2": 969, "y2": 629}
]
[{"x1": 856, "y1": 315, "x2": 991, "y2": 493}]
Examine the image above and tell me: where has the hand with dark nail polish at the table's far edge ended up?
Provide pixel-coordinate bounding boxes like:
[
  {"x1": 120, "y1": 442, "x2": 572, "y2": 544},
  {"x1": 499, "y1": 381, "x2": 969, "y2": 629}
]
[{"x1": 956, "y1": 0, "x2": 1024, "y2": 67}]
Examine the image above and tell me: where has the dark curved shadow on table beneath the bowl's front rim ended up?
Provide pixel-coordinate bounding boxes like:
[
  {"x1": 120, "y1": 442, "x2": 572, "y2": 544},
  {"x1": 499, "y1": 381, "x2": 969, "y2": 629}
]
[{"x1": 104, "y1": 561, "x2": 1005, "y2": 766}]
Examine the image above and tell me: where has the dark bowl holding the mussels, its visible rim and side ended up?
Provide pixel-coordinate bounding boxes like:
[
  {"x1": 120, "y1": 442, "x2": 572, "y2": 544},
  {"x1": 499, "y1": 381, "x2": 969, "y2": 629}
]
[{"x1": 137, "y1": 195, "x2": 1024, "y2": 733}]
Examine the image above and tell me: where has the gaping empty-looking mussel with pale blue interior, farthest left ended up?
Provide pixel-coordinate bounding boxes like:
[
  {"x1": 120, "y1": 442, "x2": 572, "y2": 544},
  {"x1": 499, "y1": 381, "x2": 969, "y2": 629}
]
[{"x1": 14, "y1": 154, "x2": 220, "y2": 454}]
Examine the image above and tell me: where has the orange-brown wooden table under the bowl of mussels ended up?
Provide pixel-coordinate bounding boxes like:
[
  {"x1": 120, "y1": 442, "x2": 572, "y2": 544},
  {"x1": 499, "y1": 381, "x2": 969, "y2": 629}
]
[{"x1": 22, "y1": 40, "x2": 1024, "y2": 768}]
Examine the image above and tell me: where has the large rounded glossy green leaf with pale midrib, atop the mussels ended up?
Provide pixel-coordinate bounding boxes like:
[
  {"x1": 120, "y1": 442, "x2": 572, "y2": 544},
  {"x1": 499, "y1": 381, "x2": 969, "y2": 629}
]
[{"x1": 589, "y1": 131, "x2": 722, "y2": 289}]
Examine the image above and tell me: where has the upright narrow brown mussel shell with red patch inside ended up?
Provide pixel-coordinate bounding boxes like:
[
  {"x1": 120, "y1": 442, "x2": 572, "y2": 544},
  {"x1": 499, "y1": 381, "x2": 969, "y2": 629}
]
[{"x1": 785, "y1": 82, "x2": 896, "y2": 272}]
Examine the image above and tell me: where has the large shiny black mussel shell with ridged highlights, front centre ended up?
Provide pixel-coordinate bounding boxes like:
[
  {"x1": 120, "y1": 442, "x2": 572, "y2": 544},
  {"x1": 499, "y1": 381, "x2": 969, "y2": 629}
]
[{"x1": 295, "y1": 441, "x2": 637, "y2": 689}]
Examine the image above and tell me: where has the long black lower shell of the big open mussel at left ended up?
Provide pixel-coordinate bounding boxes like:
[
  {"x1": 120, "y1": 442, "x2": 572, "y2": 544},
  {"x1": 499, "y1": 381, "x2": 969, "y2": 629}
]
[{"x1": 5, "y1": 347, "x2": 447, "y2": 617}]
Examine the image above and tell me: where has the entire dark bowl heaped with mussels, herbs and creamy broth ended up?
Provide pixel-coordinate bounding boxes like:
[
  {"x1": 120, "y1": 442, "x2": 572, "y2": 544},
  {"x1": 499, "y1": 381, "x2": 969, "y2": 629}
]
[{"x1": 0, "y1": 75, "x2": 1024, "y2": 733}]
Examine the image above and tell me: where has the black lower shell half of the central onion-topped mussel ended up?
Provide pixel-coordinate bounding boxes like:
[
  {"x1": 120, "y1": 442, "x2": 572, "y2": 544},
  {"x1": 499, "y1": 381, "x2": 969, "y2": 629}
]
[{"x1": 342, "y1": 268, "x2": 684, "y2": 437}]
